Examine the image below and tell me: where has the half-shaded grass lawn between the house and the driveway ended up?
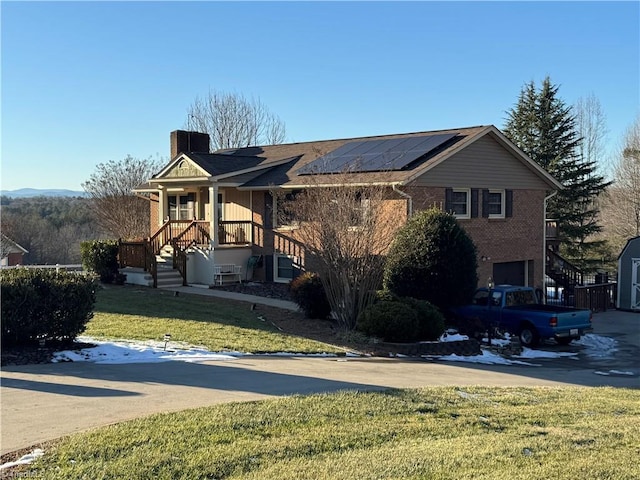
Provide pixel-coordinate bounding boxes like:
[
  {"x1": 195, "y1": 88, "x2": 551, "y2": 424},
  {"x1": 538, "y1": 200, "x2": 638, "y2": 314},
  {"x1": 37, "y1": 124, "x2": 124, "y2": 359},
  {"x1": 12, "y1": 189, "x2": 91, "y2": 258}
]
[{"x1": 83, "y1": 286, "x2": 345, "y2": 353}]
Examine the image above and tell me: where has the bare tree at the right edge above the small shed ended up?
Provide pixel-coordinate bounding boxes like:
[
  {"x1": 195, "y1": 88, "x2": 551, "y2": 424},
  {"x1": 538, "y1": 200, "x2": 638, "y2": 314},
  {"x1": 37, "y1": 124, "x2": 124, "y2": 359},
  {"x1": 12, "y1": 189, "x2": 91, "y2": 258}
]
[{"x1": 602, "y1": 117, "x2": 640, "y2": 252}]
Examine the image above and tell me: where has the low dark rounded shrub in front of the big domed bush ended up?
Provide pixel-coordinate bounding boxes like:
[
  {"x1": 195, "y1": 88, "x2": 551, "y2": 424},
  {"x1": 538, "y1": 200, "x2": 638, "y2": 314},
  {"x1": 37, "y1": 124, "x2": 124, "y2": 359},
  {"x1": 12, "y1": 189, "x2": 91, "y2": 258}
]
[{"x1": 356, "y1": 300, "x2": 418, "y2": 342}]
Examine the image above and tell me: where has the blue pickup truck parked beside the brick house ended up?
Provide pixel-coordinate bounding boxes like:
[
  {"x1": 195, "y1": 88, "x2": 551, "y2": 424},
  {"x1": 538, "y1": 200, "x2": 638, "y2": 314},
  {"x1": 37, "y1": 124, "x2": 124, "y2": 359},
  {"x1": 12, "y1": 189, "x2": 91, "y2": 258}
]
[{"x1": 452, "y1": 285, "x2": 592, "y2": 347}]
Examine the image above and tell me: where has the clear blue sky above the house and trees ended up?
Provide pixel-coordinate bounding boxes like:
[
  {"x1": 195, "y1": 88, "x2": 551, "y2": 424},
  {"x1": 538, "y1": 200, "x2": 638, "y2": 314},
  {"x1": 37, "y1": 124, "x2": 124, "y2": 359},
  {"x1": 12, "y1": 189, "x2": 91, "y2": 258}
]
[{"x1": 0, "y1": 1, "x2": 640, "y2": 190}]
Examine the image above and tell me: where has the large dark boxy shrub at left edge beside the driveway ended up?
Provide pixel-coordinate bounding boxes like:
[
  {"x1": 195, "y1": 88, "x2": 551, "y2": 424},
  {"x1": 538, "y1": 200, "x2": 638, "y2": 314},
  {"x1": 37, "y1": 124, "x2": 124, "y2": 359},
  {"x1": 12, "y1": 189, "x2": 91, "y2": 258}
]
[{"x1": 0, "y1": 268, "x2": 96, "y2": 346}]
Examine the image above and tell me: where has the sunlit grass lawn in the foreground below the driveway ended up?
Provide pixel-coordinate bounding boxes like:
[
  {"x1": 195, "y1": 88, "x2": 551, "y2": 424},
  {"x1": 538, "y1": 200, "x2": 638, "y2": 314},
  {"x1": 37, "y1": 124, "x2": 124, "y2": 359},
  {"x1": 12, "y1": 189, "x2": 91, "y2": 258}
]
[{"x1": 30, "y1": 387, "x2": 640, "y2": 480}]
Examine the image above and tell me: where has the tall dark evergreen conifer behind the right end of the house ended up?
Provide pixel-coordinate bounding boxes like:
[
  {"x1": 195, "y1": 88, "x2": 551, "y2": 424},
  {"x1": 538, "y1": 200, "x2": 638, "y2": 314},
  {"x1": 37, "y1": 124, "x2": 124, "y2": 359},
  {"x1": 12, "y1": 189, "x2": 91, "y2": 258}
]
[{"x1": 504, "y1": 77, "x2": 609, "y2": 269}]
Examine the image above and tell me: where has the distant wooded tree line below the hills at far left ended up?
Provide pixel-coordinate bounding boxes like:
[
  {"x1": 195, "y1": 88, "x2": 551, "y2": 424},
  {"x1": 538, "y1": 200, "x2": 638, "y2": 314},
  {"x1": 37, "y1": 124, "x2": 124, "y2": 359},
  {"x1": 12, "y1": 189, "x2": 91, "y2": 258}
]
[{"x1": 0, "y1": 195, "x2": 103, "y2": 265}]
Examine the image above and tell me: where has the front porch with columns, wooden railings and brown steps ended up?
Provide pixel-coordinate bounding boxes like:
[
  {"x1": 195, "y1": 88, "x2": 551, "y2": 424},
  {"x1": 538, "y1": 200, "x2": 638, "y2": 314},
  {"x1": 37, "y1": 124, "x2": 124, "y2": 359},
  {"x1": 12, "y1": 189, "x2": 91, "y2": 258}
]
[{"x1": 119, "y1": 181, "x2": 260, "y2": 287}]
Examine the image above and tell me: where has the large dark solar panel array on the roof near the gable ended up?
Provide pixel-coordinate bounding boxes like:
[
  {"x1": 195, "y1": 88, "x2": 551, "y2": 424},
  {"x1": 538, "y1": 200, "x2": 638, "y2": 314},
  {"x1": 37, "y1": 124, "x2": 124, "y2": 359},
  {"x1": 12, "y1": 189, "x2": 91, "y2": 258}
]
[{"x1": 297, "y1": 133, "x2": 457, "y2": 175}]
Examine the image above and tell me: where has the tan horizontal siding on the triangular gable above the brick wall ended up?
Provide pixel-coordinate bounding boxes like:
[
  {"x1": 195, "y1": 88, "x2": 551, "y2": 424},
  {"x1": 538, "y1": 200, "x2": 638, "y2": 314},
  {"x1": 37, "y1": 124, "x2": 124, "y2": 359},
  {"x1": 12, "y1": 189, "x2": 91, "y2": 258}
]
[{"x1": 412, "y1": 135, "x2": 549, "y2": 190}]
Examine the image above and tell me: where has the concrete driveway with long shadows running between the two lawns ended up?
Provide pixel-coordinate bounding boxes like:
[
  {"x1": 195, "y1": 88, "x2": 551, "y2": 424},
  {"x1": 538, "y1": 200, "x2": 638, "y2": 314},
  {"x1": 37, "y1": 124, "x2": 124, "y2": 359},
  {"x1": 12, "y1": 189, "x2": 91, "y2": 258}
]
[{"x1": 0, "y1": 311, "x2": 640, "y2": 453}]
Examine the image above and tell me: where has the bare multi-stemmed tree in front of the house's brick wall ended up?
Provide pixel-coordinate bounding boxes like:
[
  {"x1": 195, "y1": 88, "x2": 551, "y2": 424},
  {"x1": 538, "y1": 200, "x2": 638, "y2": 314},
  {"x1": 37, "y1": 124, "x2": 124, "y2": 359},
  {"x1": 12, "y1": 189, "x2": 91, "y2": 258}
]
[{"x1": 276, "y1": 180, "x2": 405, "y2": 330}]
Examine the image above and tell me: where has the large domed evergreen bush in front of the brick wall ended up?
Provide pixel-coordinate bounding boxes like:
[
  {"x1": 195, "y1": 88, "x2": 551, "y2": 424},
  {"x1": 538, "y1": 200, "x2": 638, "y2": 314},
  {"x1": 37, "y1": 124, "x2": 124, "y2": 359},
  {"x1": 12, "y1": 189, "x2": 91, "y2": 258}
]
[{"x1": 384, "y1": 209, "x2": 478, "y2": 312}]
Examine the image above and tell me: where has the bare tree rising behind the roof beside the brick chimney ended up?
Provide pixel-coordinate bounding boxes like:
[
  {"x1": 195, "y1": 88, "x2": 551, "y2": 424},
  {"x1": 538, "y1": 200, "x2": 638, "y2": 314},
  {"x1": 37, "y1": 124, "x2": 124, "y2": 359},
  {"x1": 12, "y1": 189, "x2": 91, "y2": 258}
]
[{"x1": 186, "y1": 91, "x2": 286, "y2": 150}]
